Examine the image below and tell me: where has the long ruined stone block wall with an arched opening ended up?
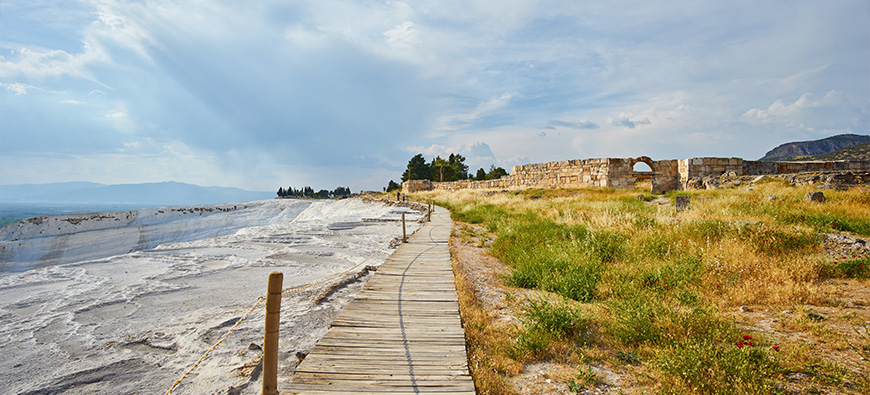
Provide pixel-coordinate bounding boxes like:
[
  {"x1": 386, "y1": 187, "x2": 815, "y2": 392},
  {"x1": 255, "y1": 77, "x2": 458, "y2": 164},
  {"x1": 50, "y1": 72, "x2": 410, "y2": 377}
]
[{"x1": 402, "y1": 157, "x2": 870, "y2": 193}]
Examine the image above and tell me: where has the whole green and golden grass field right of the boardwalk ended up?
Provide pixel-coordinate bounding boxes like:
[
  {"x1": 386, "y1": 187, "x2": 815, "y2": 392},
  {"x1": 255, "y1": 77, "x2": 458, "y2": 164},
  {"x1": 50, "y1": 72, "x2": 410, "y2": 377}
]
[{"x1": 414, "y1": 181, "x2": 870, "y2": 394}]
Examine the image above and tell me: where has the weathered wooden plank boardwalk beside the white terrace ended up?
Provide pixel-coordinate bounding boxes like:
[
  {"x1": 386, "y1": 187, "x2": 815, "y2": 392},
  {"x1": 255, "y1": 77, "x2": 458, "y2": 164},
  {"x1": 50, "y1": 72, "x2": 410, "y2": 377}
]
[{"x1": 287, "y1": 207, "x2": 475, "y2": 394}]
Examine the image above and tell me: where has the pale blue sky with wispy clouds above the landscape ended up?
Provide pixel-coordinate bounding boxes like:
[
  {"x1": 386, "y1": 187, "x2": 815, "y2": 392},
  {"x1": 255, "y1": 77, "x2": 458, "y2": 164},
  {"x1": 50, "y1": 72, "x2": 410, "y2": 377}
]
[{"x1": 0, "y1": 0, "x2": 870, "y2": 191}]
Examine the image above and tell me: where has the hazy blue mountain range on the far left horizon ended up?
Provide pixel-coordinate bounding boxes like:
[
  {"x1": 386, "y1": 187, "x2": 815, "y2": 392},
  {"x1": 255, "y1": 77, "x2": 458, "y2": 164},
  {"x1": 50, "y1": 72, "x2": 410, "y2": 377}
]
[{"x1": 0, "y1": 182, "x2": 275, "y2": 206}]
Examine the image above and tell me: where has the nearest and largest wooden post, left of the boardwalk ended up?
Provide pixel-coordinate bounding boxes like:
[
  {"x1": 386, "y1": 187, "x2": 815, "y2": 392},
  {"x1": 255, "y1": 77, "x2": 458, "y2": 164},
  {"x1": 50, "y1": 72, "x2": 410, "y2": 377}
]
[{"x1": 263, "y1": 272, "x2": 284, "y2": 395}]
